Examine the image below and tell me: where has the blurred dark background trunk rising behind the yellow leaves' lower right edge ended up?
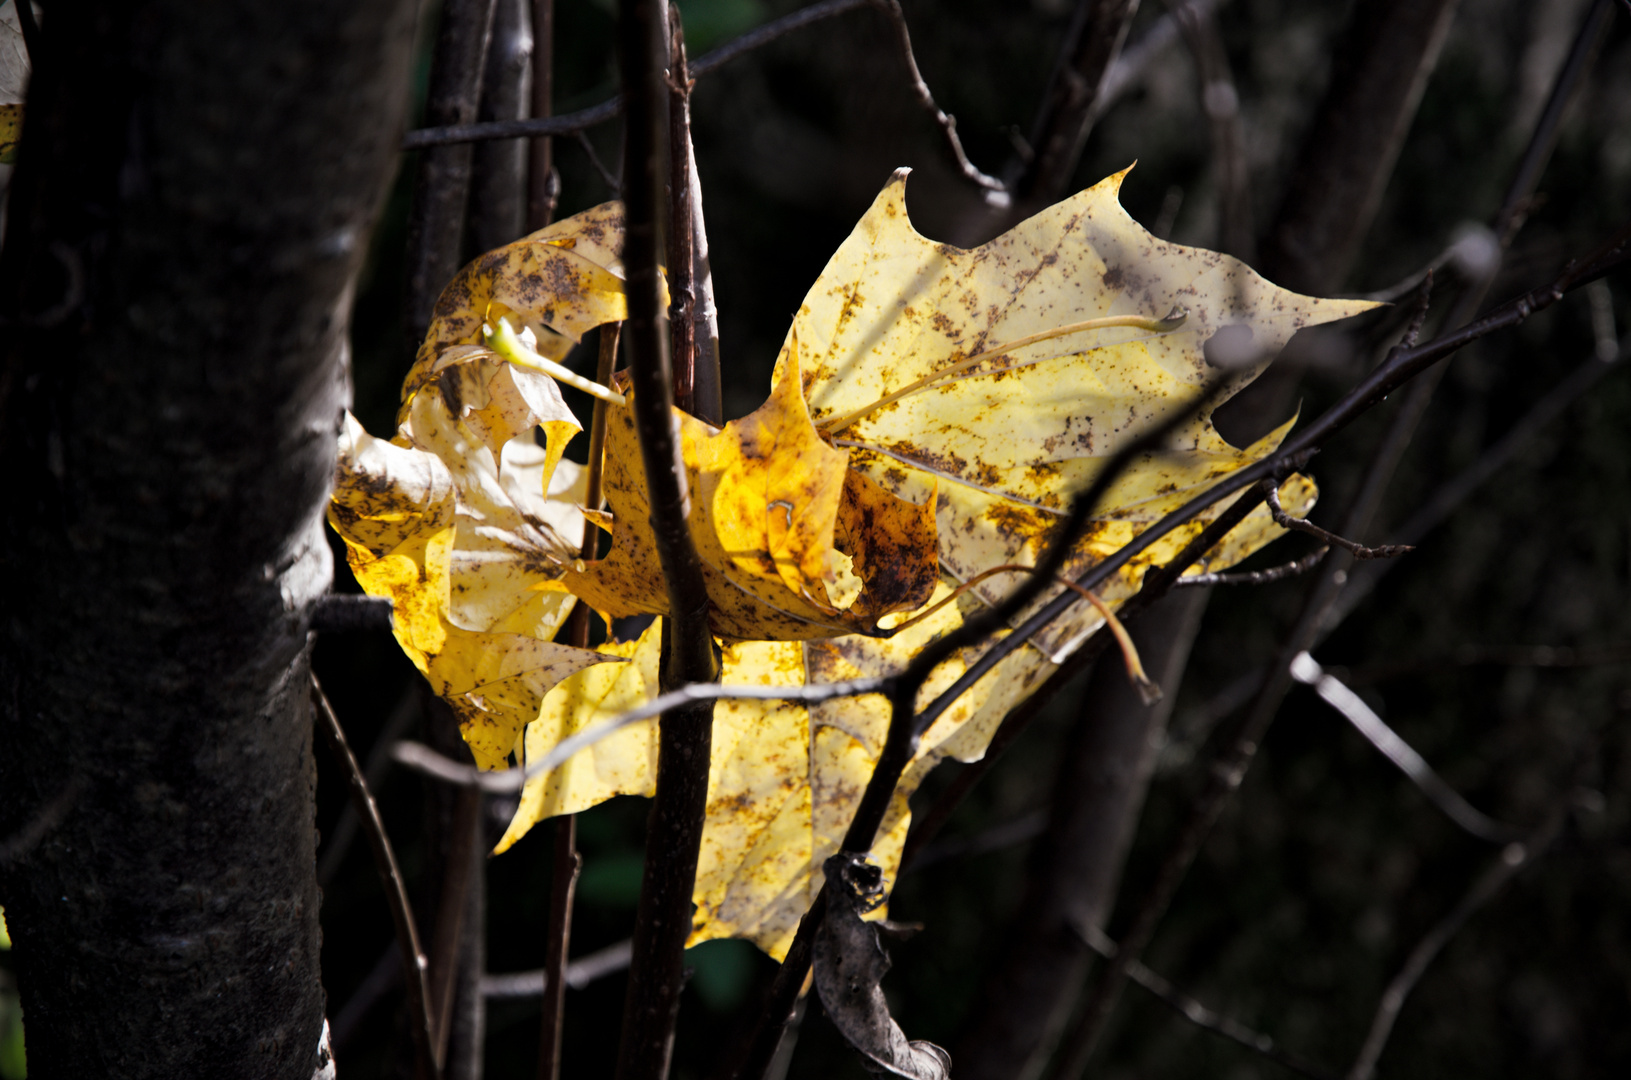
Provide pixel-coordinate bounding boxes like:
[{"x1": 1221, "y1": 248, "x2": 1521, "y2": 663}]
[{"x1": 953, "y1": 589, "x2": 1207, "y2": 1080}]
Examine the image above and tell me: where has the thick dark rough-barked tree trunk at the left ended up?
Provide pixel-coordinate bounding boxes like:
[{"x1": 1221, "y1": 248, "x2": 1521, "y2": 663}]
[{"x1": 0, "y1": 0, "x2": 427, "y2": 1080}]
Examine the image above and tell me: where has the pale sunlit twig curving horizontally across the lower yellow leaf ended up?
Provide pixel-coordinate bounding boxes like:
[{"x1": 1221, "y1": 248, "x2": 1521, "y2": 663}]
[{"x1": 391, "y1": 679, "x2": 891, "y2": 795}]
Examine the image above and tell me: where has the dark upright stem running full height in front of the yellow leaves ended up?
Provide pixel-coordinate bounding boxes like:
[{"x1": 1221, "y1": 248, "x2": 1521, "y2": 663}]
[{"x1": 617, "y1": 0, "x2": 716, "y2": 1080}]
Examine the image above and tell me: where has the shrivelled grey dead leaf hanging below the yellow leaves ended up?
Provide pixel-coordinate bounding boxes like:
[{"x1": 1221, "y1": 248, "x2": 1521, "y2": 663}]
[{"x1": 812, "y1": 852, "x2": 951, "y2": 1080}]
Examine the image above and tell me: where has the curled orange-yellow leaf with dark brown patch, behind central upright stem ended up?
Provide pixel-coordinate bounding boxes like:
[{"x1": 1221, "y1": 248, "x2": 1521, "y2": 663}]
[{"x1": 564, "y1": 340, "x2": 939, "y2": 641}]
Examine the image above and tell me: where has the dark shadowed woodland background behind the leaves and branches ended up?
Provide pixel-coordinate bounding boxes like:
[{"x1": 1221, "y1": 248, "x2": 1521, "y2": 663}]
[{"x1": 0, "y1": 0, "x2": 1631, "y2": 1080}]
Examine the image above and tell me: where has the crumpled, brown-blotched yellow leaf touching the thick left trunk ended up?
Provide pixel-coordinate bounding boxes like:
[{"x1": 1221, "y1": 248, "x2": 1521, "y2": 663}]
[{"x1": 329, "y1": 204, "x2": 642, "y2": 768}]
